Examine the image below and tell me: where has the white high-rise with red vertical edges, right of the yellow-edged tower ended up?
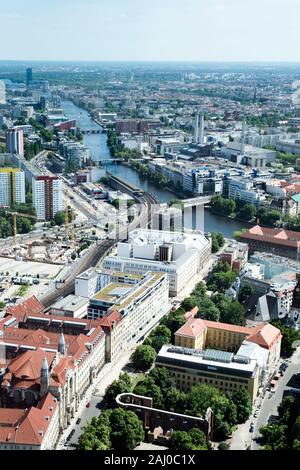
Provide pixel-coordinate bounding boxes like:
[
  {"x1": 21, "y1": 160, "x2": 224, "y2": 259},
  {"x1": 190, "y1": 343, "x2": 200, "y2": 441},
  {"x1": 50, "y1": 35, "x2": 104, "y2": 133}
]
[{"x1": 32, "y1": 176, "x2": 64, "y2": 220}]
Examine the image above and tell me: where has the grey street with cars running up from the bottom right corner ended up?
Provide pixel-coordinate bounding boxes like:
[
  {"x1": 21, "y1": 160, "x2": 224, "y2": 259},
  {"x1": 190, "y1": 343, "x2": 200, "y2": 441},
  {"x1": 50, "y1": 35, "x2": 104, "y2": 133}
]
[{"x1": 228, "y1": 348, "x2": 300, "y2": 450}]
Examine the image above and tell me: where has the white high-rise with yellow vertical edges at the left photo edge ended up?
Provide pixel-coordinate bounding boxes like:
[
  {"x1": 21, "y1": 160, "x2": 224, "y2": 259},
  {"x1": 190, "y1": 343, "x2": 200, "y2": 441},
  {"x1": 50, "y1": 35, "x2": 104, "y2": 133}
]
[{"x1": 0, "y1": 168, "x2": 26, "y2": 207}]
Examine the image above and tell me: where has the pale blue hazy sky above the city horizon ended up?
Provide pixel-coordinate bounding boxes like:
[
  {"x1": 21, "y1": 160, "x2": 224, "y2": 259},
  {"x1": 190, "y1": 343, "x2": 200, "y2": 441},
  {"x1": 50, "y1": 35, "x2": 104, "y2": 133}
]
[{"x1": 0, "y1": 0, "x2": 300, "y2": 62}]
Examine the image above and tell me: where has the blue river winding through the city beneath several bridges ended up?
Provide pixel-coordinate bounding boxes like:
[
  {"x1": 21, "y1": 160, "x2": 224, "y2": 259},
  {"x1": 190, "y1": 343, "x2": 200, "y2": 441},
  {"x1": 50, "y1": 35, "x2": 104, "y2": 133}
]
[{"x1": 62, "y1": 101, "x2": 247, "y2": 237}]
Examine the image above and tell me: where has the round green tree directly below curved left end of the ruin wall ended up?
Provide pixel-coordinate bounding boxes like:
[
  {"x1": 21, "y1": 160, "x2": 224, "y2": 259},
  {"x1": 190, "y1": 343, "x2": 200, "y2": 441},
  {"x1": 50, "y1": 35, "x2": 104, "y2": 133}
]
[{"x1": 110, "y1": 408, "x2": 145, "y2": 452}]
